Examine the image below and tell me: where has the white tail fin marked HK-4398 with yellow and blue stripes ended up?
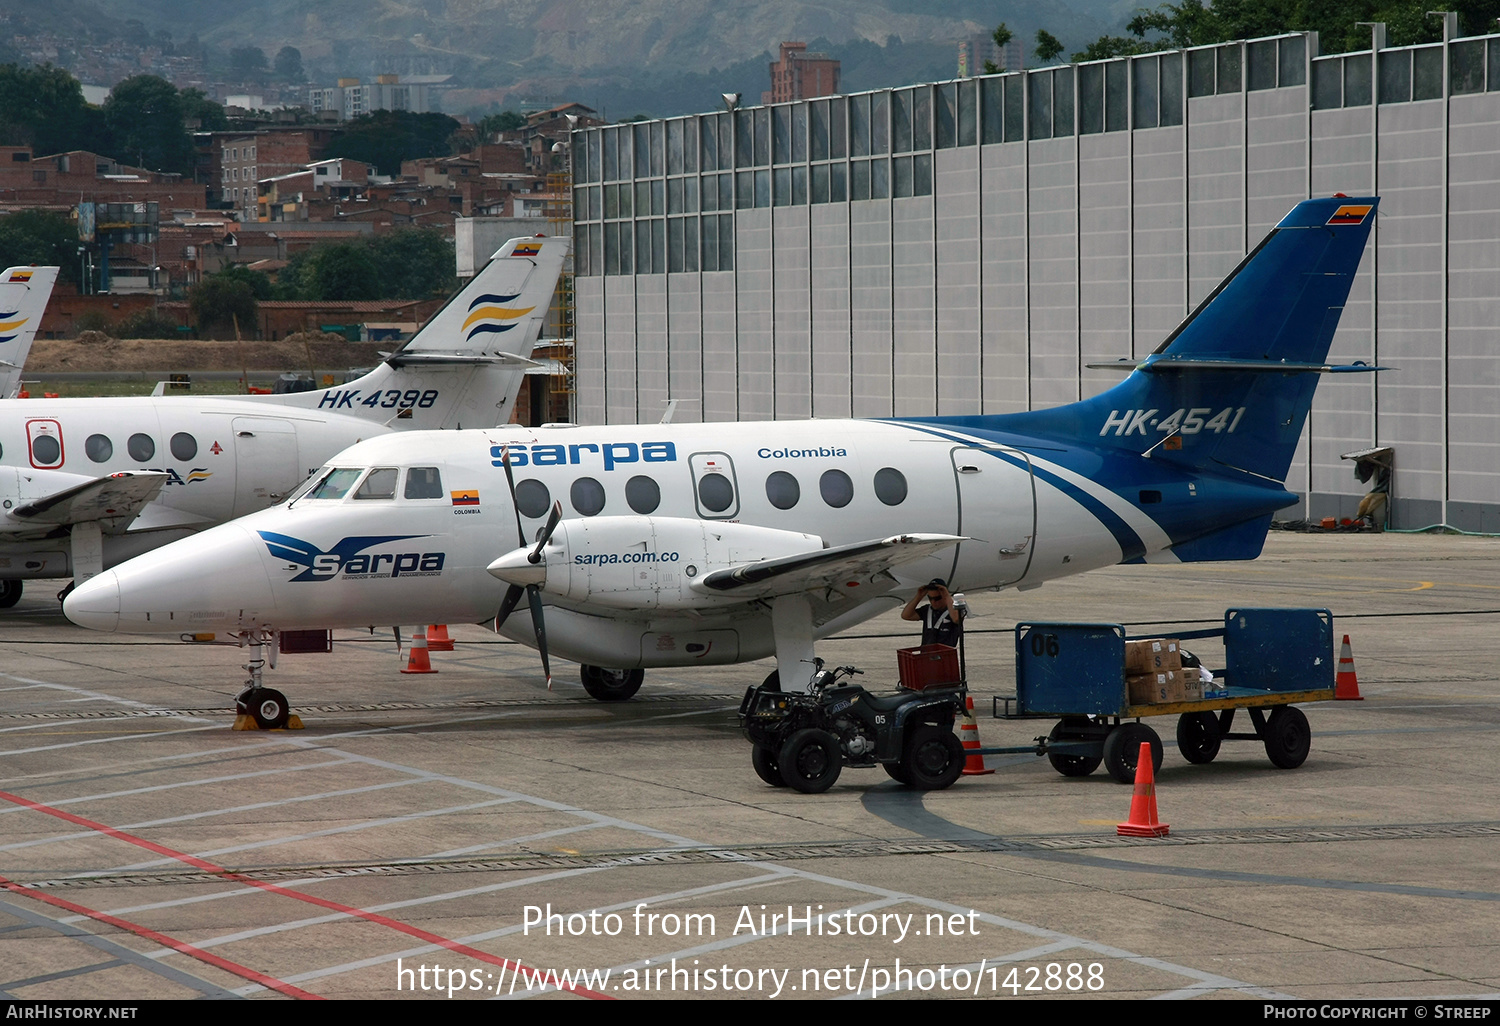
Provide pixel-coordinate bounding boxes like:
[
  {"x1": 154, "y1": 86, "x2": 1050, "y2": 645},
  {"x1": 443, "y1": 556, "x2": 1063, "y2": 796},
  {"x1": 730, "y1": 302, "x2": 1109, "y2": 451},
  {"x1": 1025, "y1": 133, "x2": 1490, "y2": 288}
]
[{"x1": 267, "y1": 236, "x2": 572, "y2": 429}]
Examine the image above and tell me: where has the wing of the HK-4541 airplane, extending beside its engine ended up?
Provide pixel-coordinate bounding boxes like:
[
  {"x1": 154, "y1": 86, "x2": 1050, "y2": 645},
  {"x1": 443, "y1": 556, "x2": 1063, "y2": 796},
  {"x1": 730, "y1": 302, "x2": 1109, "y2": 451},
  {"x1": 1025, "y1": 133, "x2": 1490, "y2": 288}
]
[{"x1": 692, "y1": 534, "x2": 965, "y2": 600}]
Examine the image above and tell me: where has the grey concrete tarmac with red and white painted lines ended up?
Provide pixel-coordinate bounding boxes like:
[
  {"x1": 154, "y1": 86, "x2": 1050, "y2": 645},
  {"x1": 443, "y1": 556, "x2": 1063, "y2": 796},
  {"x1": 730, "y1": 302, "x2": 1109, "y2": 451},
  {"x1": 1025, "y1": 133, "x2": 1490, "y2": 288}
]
[{"x1": 0, "y1": 533, "x2": 1500, "y2": 1001}]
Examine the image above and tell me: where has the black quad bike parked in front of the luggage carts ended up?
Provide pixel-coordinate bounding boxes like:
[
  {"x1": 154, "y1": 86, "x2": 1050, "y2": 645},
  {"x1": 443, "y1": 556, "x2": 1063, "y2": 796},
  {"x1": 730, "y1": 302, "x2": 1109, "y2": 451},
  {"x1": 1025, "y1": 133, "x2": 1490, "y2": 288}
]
[{"x1": 740, "y1": 659, "x2": 966, "y2": 795}]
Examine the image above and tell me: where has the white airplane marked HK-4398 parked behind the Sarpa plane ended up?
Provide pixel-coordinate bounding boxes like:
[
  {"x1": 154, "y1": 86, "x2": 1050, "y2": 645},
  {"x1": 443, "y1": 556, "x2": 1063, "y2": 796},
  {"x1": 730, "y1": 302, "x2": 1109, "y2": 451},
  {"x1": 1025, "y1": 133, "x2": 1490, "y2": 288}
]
[{"x1": 0, "y1": 237, "x2": 570, "y2": 609}]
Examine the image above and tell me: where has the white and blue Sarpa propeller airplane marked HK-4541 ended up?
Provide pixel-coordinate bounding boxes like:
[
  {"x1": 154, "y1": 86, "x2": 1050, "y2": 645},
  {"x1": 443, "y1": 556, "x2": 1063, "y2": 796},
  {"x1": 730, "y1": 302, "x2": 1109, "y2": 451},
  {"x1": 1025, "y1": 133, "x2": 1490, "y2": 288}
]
[{"x1": 63, "y1": 197, "x2": 1379, "y2": 720}]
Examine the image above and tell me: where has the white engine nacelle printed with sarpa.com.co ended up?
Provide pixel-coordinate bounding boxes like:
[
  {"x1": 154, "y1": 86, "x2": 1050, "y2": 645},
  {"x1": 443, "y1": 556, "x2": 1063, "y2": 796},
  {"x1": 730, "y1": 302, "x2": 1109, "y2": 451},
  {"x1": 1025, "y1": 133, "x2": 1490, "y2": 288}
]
[{"x1": 489, "y1": 516, "x2": 824, "y2": 609}]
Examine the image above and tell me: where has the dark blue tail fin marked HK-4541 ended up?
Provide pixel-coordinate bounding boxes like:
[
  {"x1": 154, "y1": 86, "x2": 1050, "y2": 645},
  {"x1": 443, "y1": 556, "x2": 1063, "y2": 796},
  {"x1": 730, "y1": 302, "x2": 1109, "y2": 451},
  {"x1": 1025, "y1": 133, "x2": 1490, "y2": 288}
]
[{"x1": 1004, "y1": 197, "x2": 1380, "y2": 482}]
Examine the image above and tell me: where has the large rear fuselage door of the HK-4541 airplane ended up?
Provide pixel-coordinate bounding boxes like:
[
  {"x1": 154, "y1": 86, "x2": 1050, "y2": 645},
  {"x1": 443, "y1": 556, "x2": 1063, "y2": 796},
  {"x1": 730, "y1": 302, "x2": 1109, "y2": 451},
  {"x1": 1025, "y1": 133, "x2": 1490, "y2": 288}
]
[{"x1": 951, "y1": 447, "x2": 1037, "y2": 591}]
